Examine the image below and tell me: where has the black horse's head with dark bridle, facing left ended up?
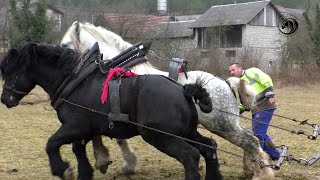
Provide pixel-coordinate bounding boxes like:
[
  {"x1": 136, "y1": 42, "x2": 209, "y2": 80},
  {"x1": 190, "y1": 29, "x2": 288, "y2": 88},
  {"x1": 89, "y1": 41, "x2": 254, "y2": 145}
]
[{"x1": 0, "y1": 44, "x2": 36, "y2": 108}]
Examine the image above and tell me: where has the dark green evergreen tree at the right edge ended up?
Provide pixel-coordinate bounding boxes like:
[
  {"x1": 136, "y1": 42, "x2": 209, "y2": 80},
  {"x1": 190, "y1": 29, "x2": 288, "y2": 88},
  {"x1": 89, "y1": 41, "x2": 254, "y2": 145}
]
[{"x1": 303, "y1": 3, "x2": 320, "y2": 67}]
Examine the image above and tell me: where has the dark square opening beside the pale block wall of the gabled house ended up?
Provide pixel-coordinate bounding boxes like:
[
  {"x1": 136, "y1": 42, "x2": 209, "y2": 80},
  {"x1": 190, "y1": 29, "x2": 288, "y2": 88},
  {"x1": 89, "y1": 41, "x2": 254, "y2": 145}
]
[{"x1": 220, "y1": 25, "x2": 242, "y2": 48}]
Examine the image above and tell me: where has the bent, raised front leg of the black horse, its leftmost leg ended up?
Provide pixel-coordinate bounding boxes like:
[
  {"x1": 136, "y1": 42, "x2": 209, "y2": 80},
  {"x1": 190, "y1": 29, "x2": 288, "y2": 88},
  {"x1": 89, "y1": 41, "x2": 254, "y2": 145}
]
[{"x1": 46, "y1": 126, "x2": 74, "y2": 180}]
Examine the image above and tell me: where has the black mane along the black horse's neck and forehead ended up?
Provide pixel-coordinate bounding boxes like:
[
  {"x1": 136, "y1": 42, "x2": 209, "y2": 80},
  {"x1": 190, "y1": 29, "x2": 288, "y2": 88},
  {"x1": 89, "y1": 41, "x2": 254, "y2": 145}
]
[{"x1": 0, "y1": 43, "x2": 80, "y2": 75}]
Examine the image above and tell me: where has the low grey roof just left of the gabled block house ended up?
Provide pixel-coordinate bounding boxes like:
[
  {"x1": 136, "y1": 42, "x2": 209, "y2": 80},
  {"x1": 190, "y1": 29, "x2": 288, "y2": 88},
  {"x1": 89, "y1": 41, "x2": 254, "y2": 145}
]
[{"x1": 149, "y1": 20, "x2": 195, "y2": 38}]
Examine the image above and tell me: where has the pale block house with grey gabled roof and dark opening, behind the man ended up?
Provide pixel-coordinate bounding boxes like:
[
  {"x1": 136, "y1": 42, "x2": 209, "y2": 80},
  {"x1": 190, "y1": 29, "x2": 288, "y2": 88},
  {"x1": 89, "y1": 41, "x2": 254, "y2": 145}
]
[{"x1": 190, "y1": 0, "x2": 286, "y2": 71}]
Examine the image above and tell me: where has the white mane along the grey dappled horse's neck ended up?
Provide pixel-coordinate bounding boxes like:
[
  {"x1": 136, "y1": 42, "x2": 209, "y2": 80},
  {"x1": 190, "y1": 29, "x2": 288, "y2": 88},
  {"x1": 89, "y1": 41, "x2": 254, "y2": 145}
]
[{"x1": 80, "y1": 22, "x2": 132, "y2": 51}]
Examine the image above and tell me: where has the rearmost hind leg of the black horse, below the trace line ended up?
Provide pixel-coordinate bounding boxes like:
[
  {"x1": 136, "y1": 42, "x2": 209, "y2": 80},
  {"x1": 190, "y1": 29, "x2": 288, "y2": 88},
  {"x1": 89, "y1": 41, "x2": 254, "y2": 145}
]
[{"x1": 188, "y1": 131, "x2": 223, "y2": 180}]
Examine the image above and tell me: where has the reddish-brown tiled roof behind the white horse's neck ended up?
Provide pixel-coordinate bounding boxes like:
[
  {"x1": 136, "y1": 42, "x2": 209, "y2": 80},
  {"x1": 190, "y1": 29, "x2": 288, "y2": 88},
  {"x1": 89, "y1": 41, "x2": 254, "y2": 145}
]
[{"x1": 101, "y1": 13, "x2": 173, "y2": 37}]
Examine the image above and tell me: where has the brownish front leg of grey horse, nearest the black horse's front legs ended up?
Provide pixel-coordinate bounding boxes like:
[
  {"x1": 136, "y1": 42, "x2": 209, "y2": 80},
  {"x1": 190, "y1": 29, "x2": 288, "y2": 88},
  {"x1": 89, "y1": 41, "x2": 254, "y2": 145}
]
[{"x1": 92, "y1": 136, "x2": 112, "y2": 174}]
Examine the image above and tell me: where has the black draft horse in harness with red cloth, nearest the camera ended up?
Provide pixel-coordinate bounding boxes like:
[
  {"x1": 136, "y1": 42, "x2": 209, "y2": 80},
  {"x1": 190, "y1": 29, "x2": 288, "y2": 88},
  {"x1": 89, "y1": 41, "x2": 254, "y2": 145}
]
[{"x1": 0, "y1": 43, "x2": 222, "y2": 179}]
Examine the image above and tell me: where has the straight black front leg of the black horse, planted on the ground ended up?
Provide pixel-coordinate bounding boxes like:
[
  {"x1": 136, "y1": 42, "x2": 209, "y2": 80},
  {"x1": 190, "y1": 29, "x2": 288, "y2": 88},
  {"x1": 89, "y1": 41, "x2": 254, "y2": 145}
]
[{"x1": 72, "y1": 141, "x2": 93, "y2": 180}]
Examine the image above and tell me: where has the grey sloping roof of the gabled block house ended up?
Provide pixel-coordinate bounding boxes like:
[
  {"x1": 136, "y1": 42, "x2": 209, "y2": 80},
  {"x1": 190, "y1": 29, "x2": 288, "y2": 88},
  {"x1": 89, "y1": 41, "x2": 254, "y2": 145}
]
[{"x1": 192, "y1": 0, "x2": 278, "y2": 28}]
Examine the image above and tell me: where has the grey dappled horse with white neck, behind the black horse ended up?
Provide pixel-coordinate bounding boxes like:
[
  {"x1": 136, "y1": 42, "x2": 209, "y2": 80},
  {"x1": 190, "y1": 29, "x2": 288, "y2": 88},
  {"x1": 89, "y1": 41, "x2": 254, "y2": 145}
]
[{"x1": 61, "y1": 21, "x2": 274, "y2": 179}]
